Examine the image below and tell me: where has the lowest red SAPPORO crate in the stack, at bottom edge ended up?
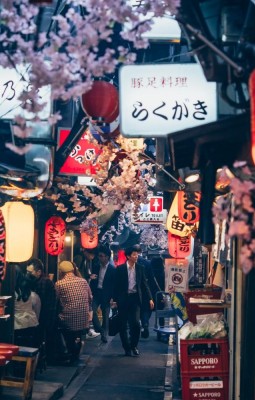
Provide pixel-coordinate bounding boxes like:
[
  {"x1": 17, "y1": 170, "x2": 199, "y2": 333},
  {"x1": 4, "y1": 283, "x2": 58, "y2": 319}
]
[{"x1": 181, "y1": 375, "x2": 229, "y2": 400}]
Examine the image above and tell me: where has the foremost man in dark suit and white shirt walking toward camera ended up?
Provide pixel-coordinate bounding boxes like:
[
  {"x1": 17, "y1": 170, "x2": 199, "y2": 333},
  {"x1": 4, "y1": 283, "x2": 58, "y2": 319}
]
[{"x1": 113, "y1": 246, "x2": 154, "y2": 356}]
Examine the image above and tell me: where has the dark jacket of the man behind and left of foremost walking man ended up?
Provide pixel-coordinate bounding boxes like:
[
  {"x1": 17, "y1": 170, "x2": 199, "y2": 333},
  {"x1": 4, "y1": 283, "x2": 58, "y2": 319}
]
[{"x1": 90, "y1": 263, "x2": 116, "y2": 302}]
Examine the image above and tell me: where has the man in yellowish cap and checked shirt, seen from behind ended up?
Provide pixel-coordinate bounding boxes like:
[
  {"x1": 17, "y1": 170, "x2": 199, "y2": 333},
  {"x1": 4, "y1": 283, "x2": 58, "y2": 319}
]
[{"x1": 55, "y1": 261, "x2": 92, "y2": 363}]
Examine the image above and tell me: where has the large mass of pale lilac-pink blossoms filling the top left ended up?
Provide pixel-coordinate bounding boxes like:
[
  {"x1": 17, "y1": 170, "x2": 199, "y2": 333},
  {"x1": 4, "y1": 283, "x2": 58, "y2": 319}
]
[{"x1": 0, "y1": 0, "x2": 179, "y2": 130}]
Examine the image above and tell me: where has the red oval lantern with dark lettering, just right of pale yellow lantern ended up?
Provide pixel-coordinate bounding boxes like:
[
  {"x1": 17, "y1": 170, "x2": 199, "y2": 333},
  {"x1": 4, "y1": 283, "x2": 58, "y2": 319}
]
[{"x1": 45, "y1": 216, "x2": 66, "y2": 256}]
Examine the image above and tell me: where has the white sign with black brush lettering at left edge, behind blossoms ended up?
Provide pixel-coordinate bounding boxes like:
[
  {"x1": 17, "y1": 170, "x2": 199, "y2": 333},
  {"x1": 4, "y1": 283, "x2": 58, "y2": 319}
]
[{"x1": 0, "y1": 65, "x2": 51, "y2": 120}]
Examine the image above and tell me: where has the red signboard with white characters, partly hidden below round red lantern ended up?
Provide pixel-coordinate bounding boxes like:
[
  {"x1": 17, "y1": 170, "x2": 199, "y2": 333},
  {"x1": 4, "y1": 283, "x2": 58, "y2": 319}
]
[{"x1": 58, "y1": 129, "x2": 101, "y2": 176}]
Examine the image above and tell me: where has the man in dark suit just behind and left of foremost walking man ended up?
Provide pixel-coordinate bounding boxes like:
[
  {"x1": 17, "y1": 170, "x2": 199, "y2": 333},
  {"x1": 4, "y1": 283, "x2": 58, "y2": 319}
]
[{"x1": 90, "y1": 245, "x2": 116, "y2": 343}]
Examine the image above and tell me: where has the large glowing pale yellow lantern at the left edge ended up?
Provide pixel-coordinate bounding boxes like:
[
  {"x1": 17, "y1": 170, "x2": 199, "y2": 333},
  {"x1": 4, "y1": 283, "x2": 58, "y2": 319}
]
[{"x1": 1, "y1": 201, "x2": 34, "y2": 262}]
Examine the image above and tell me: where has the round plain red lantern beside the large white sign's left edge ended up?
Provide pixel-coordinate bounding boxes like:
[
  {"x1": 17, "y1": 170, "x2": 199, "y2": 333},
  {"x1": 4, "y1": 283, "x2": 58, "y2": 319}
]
[{"x1": 81, "y1": 81, "x2": 119, "y2": 124}]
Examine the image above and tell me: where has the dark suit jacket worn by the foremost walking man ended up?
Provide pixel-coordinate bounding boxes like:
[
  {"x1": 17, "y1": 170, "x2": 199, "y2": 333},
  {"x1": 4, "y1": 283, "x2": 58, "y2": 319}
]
[{"x1": 113, "y1": 263, "x2": 152, "y2": 306}]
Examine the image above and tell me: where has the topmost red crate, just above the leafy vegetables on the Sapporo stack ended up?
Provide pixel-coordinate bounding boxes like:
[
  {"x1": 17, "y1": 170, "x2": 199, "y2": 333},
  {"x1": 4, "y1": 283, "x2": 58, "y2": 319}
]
[{"x1": 184, "y1": 287, "x2": 223, "y2": 324}]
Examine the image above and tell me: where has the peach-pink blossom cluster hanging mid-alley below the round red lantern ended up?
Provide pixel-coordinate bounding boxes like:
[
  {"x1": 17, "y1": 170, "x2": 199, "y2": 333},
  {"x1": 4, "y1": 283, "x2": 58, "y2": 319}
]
[{"x1": 45, "y1": 136, "x2": 154, "y2": 228}]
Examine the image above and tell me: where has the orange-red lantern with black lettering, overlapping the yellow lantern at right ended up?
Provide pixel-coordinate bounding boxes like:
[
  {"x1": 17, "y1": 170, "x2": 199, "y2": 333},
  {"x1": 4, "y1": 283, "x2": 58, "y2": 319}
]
[{"x1": 177, "y1": 190, "x2": 201, "y2": 225}]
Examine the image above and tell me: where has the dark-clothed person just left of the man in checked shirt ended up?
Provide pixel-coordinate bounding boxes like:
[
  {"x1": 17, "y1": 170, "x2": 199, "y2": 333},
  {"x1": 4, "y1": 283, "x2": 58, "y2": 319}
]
[{"x1": 26, "y1": 258, "x2": 57, "y2": 363}]
